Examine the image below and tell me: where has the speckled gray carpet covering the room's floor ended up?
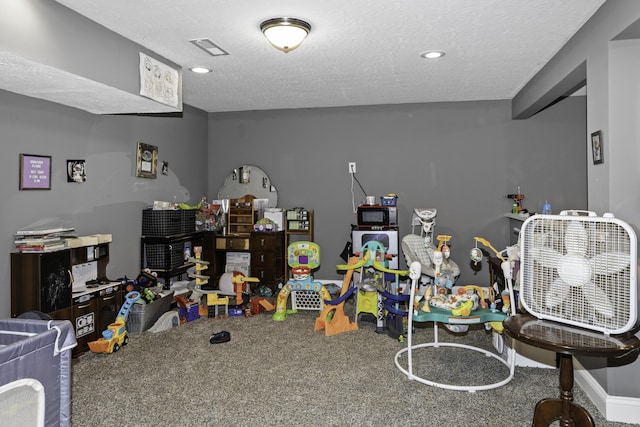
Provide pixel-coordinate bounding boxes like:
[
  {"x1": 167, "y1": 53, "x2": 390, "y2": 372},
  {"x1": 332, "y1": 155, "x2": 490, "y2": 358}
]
[{"x1": 72, "y1": 304, "x2": 629, "y2": 427}]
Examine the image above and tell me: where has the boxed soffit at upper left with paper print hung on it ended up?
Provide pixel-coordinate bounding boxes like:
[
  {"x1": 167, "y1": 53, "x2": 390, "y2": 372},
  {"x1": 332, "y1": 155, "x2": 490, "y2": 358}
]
[{"x1": 0, "y1": 0, "x2": 182, "y2": 114}]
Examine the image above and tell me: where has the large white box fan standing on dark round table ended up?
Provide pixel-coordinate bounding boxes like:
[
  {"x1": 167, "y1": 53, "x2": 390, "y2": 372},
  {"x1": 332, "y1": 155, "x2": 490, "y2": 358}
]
[{"x1": 520, "y1": 211, "x2": 638, "y2": 334}]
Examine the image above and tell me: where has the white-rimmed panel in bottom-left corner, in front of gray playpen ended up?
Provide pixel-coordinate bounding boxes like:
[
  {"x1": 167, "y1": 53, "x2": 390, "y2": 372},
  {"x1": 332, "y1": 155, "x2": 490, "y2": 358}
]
[{"x1": 0, "y1": 378, "x2": 45, "y2": 427}]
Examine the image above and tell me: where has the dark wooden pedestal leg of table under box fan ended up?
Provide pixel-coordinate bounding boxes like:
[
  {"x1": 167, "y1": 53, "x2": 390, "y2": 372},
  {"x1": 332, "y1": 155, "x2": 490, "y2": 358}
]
[{"x1": 532, "y1": 354, "x2": 595, "y2": 427}]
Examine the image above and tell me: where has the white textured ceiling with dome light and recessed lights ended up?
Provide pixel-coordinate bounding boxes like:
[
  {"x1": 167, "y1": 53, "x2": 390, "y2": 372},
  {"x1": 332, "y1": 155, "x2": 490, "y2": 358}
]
[{"x1": 33, "y1": 0, "x2": 604, "y2": 112}]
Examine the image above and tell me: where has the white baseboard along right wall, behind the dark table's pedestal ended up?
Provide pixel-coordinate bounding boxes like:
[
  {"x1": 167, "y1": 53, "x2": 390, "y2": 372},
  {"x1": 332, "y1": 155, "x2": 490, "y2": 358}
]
[{"x1": 573, "y1": 358, "x2": 640, "y2": 424}]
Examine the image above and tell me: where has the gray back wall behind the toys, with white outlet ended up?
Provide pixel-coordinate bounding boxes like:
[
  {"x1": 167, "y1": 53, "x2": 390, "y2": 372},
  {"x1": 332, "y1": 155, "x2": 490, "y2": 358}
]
[{"x1": 208, "y1": 97, "x2": 587, "y2": 284}]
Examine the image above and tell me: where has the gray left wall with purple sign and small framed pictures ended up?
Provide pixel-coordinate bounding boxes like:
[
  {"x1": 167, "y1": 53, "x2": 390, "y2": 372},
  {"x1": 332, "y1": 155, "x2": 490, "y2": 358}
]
[{"x1": 0, "y1": 91, "x2": 207, "y2": 317}]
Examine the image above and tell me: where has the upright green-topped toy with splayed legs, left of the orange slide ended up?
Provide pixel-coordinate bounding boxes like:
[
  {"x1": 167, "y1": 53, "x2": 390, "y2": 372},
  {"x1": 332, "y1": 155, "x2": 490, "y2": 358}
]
[{"x1": 273, "y1": 241, "x2": 331, "y2": 321}]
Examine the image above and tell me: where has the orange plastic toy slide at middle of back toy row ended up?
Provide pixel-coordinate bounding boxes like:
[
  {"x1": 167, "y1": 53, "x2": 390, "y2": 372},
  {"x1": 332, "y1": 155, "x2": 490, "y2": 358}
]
[{"x1": 313, "y1": 257, "x2": 362, "y2": 336}]
